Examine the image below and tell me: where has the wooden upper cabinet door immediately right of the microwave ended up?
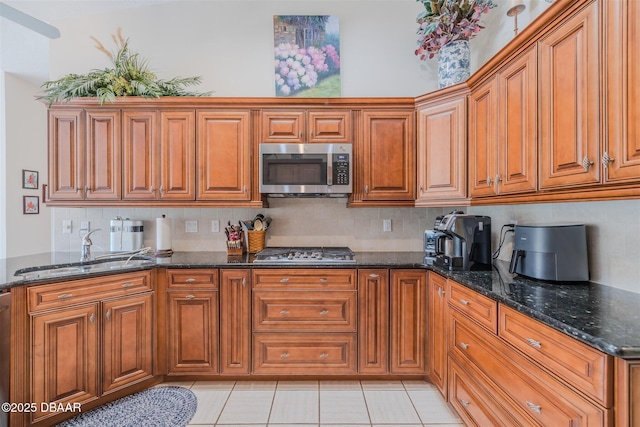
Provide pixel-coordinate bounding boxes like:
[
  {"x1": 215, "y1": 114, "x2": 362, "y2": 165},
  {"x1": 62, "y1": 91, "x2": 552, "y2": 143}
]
[{"x1": 354, "y1": 111, "x2": 416, "y2": 202}]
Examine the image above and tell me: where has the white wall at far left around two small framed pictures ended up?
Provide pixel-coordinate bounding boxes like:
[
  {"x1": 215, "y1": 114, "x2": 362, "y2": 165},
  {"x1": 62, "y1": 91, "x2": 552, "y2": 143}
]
[{"x1": 2, "y1": 73, "x2": 51, "y2": 257}]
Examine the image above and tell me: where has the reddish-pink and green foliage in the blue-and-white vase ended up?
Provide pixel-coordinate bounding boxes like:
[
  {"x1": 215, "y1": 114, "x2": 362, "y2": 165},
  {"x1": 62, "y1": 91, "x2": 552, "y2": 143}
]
[{"x1": 415, "y1": 0, "x2": 497, "y2": 60}]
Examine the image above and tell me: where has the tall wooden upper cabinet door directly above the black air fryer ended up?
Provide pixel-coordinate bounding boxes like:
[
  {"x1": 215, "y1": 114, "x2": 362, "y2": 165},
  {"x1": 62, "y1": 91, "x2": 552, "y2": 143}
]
[{"x1": 539, "y1": 2, "x2": 600, "y2": 189}]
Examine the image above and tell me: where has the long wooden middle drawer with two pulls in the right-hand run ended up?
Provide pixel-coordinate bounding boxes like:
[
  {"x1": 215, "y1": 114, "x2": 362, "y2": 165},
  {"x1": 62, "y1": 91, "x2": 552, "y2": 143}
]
[{"x1": 449, "y1": 312, "x2": 611, "y2": 427}]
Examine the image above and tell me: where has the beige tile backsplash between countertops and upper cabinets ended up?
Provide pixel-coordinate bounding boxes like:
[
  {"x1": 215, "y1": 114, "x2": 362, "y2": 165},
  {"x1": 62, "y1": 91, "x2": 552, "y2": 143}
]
[{"x1": 52, "y1": 198, "x2": 640, "y2": 293}]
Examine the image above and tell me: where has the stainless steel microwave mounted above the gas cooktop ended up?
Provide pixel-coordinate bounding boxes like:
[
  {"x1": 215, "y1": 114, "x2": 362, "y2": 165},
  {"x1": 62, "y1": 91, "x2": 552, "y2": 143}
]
[{"x1": 259, "y1": 143, "x2": 353, "y2": 197}]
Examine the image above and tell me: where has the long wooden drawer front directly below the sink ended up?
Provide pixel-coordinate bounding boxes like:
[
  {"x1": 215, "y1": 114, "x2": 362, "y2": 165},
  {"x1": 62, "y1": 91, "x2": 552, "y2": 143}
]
[{"x1": 27, "y1": 271, "x2": 152, "y2": 312}]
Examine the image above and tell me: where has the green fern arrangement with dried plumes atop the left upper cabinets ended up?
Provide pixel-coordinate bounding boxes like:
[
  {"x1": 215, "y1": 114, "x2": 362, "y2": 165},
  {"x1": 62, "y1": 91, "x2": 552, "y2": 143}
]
[{"x1": 38, "y1": 28, "x2": 210, "y2": 105}]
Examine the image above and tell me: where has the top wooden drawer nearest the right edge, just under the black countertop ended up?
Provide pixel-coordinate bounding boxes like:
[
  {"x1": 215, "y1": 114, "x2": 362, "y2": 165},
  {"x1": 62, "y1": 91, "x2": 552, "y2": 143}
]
[{"x1": 498, "y1": 304, "x2": 613, "y2": 408}]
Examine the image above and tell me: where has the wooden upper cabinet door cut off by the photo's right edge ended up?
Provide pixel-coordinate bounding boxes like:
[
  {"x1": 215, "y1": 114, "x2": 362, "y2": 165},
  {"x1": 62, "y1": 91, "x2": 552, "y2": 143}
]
[{"x1": 602, "y1": 0, "x2": 640, "y2": 182}]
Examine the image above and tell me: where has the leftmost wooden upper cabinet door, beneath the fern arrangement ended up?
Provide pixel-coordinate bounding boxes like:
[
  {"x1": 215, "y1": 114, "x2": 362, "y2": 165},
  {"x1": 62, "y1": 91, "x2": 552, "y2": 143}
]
[{"x1": 48, "y1": 110, "x2": 85, "y2": 200}]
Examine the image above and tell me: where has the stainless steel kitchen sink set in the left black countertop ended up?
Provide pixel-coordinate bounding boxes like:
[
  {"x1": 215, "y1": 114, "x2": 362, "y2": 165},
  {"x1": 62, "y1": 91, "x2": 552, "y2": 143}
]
[{"x1": 14, "y1": 258, "x2": 155, "y2": 280}]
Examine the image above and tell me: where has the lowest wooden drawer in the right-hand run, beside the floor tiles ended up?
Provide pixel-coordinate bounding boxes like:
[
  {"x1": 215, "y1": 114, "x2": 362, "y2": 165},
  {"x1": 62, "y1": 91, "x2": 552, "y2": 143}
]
[{"x1": 449, "y1": 359, "x2": 523, "y2": 427}]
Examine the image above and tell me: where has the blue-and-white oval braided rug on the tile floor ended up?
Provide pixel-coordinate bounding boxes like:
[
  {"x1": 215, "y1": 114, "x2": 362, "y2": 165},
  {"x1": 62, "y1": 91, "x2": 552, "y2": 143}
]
[{"x1": 58, "y1": 386, "x2": 198, "y2": 427}]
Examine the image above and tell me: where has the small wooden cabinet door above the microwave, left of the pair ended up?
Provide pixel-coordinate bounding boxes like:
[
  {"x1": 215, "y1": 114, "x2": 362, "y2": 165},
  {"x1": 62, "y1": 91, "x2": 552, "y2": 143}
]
[{"x1": 260, "y1": 110, "x2": 305, "y2": 143}]
